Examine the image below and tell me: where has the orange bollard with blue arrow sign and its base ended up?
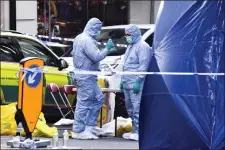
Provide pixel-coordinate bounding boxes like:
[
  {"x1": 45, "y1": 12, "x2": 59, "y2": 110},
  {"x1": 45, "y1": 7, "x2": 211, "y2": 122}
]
[{"x1": 7, "y1": 57, "x2": 51, "y2": 148}]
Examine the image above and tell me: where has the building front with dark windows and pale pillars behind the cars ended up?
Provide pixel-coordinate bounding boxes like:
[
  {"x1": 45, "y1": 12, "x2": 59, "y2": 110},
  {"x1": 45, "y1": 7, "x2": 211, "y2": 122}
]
[{"x1": 1, "y1": 0, "x2": 160, "y2": 37}]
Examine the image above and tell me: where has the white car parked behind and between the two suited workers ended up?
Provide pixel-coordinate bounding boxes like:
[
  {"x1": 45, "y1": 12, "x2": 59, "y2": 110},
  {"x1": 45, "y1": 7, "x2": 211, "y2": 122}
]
[{"x1": 61, "y1": 24, "x2": 155, "y2": 118}]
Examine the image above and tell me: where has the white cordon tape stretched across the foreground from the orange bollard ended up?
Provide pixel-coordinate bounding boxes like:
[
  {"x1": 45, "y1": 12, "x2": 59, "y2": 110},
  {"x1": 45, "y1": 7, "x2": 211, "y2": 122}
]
[{"x1": 20, "y1": 67, "x2": 225, "y2": 80}]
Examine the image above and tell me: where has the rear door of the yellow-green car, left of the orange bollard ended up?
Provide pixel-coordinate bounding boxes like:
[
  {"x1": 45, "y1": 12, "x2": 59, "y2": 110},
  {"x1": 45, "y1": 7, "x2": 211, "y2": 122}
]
[{"x1": 0, "y1": 36, "x2": 23, "y2": 104}]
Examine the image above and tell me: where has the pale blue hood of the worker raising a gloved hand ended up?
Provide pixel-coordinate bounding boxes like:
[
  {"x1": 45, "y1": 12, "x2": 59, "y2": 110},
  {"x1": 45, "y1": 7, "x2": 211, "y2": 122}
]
[{"x1": 84, "y1": 18, "x2": 102, "y2": 38}]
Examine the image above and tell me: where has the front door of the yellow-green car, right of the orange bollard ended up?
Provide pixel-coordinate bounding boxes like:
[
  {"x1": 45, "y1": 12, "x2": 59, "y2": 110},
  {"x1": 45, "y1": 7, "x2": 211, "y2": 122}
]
[{"x1": 12, "y1": 37, "x2": 73, "y2": 106}]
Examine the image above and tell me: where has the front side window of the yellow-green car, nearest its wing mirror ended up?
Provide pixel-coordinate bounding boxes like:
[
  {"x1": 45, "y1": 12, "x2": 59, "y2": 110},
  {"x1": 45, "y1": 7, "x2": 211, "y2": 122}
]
[{"x1": 16, "y1": 38, "x2": 57, "y2": 67}]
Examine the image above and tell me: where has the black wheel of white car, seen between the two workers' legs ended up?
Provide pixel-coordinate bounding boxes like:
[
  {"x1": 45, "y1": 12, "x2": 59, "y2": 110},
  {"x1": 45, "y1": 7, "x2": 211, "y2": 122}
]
[{"x1": 114, "y1": 93, "x2": 129, "y2": 119}]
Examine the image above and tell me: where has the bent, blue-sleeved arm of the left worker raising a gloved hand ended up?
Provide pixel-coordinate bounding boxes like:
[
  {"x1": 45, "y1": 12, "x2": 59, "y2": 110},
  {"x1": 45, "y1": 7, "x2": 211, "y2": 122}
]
[{"x1": 84, "y1": 40, "x2": 108, "y2": 63}]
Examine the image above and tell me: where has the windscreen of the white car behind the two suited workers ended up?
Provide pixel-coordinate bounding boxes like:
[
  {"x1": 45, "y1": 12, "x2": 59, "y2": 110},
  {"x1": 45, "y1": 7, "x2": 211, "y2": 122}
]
[{"x1": 96, "y1": 29, "x2": 149, "y2": 56}]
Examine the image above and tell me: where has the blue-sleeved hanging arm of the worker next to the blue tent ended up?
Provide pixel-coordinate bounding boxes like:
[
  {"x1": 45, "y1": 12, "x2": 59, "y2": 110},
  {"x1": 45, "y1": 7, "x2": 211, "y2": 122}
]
[{"x1": 138, "y1": 45, "x2": 153, "y2": 81}]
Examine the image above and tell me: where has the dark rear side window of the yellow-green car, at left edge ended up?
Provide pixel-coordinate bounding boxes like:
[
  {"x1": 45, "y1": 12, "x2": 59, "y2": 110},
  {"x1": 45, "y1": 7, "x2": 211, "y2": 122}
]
[{"x1": 0, "y1": 37, "x2": 23, "y2": 62}]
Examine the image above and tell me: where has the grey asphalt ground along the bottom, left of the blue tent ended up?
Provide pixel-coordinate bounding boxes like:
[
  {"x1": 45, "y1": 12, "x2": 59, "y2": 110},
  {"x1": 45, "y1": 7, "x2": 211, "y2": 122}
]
[{"x1": 1, "y1": 136, "x2": 138, "y2": 149}]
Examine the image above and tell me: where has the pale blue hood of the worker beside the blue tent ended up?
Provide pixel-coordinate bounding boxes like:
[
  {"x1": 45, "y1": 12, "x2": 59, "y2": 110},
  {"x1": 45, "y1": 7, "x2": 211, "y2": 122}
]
[{"x1": 125, "y1": 24, "x2": 141, "y2": 44}]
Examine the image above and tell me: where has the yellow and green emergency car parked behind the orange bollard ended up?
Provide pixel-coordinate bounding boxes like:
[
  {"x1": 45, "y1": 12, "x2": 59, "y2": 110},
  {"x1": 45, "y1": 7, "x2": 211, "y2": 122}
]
[{"x1": 0, "y1": 31, "x2": 109, "y2": 122}]
